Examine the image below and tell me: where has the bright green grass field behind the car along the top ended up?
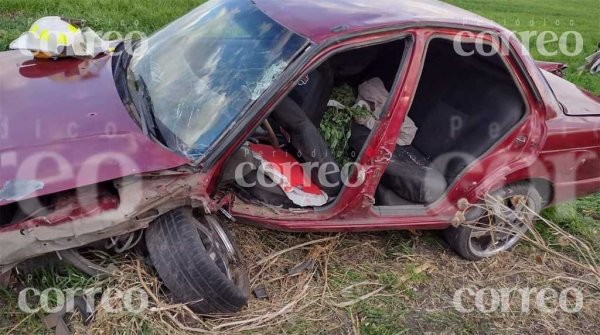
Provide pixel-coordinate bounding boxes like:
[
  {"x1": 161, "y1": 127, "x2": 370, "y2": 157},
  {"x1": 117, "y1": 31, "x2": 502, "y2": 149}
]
[{"x1": 0, "y1": 0, "x2": 600, "y2": 94}]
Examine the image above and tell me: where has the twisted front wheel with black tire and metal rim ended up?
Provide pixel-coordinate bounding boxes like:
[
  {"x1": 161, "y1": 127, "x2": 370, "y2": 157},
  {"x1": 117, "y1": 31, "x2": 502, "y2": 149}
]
[{"x1": 146, "y1": 208, "x2": 248, "y2": 314}]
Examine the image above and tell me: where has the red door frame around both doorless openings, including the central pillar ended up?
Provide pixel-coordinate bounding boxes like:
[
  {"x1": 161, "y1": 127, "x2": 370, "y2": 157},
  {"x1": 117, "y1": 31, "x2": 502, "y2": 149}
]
[{"x1": 227, "y1": 27, "x2": 545, "y2": 231}]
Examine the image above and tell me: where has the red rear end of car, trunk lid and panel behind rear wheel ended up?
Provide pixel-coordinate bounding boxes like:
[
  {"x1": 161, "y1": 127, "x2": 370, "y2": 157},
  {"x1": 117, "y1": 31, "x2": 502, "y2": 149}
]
[{"x1": 509, "y1": 71, "x2": 600, "y2": 203}]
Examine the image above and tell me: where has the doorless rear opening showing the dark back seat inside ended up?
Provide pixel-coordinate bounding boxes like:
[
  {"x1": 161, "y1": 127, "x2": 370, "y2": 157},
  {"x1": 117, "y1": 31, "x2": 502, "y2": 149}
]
[{"x1": 375, "y1": 38, "x2": 526, "y2": 206}]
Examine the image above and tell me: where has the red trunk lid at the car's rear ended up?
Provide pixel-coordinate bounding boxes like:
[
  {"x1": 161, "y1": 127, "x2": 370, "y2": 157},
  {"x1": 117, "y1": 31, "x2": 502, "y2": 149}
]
[{"x1": 542, "y1": 70, "x2": 600, "y2": 116}]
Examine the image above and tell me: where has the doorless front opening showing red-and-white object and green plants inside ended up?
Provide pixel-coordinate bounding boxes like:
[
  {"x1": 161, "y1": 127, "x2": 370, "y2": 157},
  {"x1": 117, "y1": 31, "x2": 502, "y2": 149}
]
[{"x1": 221, "y1": 39, "x2": 407, "y2": 208}]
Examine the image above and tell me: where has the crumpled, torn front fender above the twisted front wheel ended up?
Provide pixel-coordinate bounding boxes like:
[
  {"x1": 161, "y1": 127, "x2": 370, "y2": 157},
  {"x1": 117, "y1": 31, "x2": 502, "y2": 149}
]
[{"x1": 0, "y1": 171, "x2": 217, "y2": 273}]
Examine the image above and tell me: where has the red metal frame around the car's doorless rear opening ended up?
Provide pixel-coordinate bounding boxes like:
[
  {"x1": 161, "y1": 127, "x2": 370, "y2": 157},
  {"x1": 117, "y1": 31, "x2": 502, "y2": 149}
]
[{"x1": 373, "y1": 27, "x2": 546, "y2": 222}]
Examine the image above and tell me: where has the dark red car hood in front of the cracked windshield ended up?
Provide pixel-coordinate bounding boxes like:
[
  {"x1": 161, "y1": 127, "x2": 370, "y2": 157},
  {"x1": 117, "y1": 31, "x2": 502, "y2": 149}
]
[{"x1": 0, "y1": 51, "x2": 187, "y2": 205}]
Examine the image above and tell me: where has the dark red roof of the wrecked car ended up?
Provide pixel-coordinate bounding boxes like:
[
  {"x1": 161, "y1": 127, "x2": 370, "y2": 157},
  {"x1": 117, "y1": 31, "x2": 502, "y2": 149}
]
[{"x1": 253, "y1": 0, "x2": 503, "y2": 43}]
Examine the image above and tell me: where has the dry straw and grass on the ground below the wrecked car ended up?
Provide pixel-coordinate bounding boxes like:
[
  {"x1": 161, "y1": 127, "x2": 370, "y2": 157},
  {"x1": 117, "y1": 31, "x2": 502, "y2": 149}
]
[{"x1": 4, "y1": 198, "x2": 600, "y2": 334}]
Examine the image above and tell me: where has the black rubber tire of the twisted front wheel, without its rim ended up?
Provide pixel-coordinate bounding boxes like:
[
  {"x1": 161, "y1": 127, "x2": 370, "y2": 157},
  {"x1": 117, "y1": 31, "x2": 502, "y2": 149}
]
[{"x1": 146, "y1": 208, "x2": 248, "y2": 314}]
